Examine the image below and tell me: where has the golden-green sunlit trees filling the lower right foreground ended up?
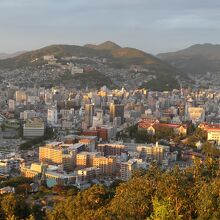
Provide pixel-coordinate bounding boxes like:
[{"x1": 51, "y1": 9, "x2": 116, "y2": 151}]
[{"x1": 47, "y1": 158, "x2": 220, "y2": 220}]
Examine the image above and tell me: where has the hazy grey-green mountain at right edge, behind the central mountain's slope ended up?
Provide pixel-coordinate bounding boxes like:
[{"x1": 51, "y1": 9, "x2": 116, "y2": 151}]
[{"x1": 158, "y1": 44, "x2": 220, "y2": 74}]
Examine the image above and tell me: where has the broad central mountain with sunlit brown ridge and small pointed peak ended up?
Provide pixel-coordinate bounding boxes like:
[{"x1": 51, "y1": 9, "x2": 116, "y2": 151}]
[{"x1": 0, "y1": 41, "x2": 186, "y2": 90}]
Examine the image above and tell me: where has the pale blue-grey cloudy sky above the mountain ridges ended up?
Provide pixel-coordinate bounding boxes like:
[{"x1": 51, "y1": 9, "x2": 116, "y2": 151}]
[{"x1": 0, "y1": 0, "x2": 220, "y2": 54}]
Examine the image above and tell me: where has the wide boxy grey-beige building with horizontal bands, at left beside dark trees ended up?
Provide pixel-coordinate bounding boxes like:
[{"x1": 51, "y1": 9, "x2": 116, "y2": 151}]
[{"x1": 23, "y1": 118, "x2": 45, "y2": 138}]
